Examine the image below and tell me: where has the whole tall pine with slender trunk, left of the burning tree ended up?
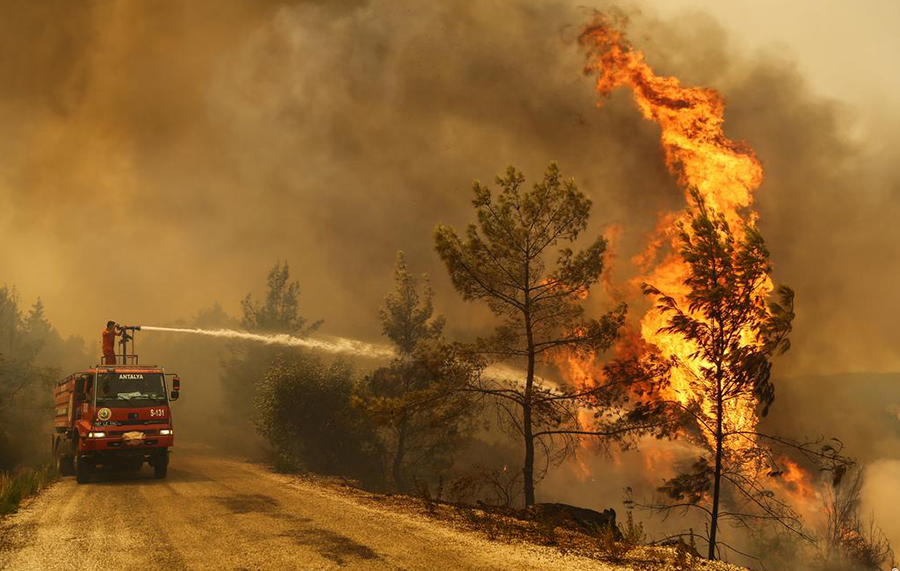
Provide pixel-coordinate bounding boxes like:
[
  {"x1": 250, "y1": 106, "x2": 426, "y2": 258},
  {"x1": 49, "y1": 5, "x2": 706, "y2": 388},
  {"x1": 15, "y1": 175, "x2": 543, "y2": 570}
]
[{"x1": 435, "y1": 163, "x2": 625, "y2": 505}]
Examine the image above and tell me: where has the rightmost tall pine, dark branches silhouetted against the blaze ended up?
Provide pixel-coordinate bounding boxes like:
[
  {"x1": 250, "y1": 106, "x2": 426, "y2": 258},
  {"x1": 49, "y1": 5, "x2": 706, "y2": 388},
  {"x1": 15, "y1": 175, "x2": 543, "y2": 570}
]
[{"x1": 644, "y1": 191, "x2": 800, "y2": 559}]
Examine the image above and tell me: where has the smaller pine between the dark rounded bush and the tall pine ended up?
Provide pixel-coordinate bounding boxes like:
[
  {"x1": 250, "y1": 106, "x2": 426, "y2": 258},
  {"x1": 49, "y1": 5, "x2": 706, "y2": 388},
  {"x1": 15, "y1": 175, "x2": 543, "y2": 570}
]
[{"x1": 353, "y1": 252, "x2": 471, "y2": 492}]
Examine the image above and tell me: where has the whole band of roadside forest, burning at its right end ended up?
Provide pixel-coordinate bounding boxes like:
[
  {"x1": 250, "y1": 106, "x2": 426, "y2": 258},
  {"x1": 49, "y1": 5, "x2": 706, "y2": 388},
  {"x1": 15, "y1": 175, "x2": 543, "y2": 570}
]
[{"x1": 0, "y1": 163, "x2": 893, "y2": 569}]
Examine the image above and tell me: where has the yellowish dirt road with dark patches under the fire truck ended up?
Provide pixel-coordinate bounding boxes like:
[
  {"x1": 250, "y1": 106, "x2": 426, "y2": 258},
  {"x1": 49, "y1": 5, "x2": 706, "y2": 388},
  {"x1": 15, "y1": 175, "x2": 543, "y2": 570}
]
[{"x1": 0, "y1": 448, "x2": 611, "y2": 571}]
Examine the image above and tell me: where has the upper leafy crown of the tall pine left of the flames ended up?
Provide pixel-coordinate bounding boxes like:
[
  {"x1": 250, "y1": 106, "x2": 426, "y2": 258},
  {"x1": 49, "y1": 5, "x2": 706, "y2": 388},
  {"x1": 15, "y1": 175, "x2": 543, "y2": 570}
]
[{"x1": 434, "y1": 163, "x2": 625, "y2": 359}]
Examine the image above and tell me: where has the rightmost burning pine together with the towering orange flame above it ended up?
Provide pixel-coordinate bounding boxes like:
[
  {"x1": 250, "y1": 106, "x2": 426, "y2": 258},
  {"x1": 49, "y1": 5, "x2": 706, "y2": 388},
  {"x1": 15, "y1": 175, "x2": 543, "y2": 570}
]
[{"x1": 579, "y1": 13, "x2": 849, "y2": 558}]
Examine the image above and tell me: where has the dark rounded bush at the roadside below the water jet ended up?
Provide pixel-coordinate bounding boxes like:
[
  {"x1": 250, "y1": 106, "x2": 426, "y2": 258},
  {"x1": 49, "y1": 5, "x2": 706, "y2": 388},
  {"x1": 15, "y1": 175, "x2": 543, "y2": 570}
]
[{"x1": 255, "y1": 353, "x2": 381, "y2": 483}]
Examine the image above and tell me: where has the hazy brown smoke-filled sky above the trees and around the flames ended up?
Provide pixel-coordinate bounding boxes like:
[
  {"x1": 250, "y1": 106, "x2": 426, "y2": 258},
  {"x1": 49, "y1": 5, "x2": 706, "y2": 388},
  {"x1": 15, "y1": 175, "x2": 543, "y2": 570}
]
[{"x1": 0, "y1": 0, "x2": 900, "y2": 371}]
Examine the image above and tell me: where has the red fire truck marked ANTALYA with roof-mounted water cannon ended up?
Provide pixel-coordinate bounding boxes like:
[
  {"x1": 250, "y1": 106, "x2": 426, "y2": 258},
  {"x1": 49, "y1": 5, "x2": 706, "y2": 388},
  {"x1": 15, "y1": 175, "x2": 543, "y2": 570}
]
[{"x1": 52, "y1": 326, "x2": 181, "y2": 484}]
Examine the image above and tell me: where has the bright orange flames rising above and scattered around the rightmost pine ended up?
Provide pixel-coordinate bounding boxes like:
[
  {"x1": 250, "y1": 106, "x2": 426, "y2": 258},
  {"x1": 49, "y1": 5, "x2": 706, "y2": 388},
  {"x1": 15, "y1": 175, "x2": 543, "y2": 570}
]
[{"x1": 557, "y1": 16, "x2": 821, "y2": 520}]
